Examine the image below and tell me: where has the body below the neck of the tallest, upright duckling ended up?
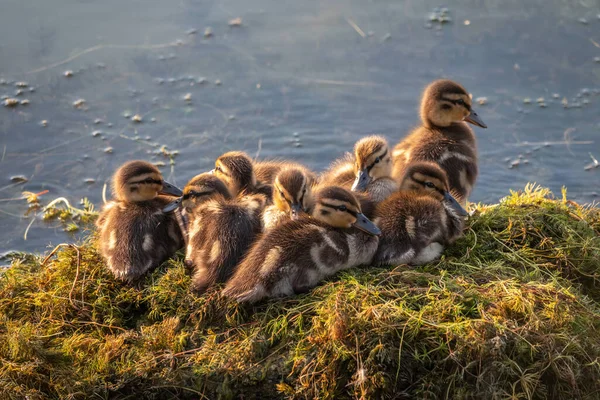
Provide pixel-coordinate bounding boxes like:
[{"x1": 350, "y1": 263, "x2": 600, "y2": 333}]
[{"x1": 392, "y1": 122, "x2": 478, "y2": 204}]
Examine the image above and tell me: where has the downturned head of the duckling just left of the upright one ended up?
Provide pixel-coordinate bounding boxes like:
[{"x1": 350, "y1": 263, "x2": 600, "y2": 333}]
[{"x1": 352, "y1": 136, "x2": 392, "y2": 192}]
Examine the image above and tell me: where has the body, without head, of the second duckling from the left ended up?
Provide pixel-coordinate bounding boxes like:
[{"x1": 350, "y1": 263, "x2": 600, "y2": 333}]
[{"x1": 186, "y1": 195, "x2": 265, "y2": 292}]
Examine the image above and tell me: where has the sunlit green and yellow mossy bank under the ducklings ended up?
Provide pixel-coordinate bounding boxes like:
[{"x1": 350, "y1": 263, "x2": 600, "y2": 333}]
[{"x1": 0, "y1": 187, "x2": 600, "y2": 399}]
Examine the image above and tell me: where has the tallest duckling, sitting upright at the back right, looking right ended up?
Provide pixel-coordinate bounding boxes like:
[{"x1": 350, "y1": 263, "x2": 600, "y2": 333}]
[{"x1": 393, "y1": 79, "x2": 487, "y2": 205}]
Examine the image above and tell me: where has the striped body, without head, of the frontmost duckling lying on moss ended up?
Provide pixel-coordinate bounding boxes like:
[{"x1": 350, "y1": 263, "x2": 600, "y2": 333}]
[{"x1": 223, "y1": 217, "x2": 378, "y2": 303}]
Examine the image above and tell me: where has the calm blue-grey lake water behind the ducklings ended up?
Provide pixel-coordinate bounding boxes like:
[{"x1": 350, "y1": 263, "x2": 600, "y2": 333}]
[{"x1": 0, "y1": 0, "x2": 600, "y2": 253}]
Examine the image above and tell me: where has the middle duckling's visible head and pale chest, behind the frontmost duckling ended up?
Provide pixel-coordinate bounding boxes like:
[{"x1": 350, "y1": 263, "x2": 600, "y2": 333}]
[{"x1": 262, "y1": 168, "x2": 314, "y2": 231}]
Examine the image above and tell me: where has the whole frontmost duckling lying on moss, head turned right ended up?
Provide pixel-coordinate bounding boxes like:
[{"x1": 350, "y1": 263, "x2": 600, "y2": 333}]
[{"x1": 223, "y1": 186, "x2": 380, "y2": 303}]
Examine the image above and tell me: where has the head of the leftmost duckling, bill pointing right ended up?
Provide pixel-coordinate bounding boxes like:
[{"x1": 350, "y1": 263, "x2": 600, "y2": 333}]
[{"x1": 113, "y1": 160, "x2": 182, "y2": 202}]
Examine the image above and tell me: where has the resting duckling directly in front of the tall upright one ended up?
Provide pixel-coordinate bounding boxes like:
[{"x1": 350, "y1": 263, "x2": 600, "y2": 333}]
[{"x1": 373, "y1": 162, "x2": 467, "y2": 265}]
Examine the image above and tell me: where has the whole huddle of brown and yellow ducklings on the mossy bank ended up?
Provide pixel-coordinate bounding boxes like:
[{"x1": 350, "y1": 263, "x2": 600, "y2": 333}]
[{"x1": 97, "y1": 80, "x2": 486, "y2": 303}]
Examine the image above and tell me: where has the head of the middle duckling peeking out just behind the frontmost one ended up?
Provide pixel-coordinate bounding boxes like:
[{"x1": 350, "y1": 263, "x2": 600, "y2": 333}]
[{"x1": 273, "y1": 168, "x2": 311, "y2": 219}]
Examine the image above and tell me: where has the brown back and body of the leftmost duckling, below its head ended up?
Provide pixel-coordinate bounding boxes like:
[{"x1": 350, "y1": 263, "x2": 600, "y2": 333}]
[{"x1": 97, "y1": 197, "x2": 183, "y2": 282}]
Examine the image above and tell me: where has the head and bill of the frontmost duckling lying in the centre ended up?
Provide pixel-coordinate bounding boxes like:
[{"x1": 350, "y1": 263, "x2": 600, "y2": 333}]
[{"x1": 312, "y1": 186, "x2": 381, "y2": 235}]
